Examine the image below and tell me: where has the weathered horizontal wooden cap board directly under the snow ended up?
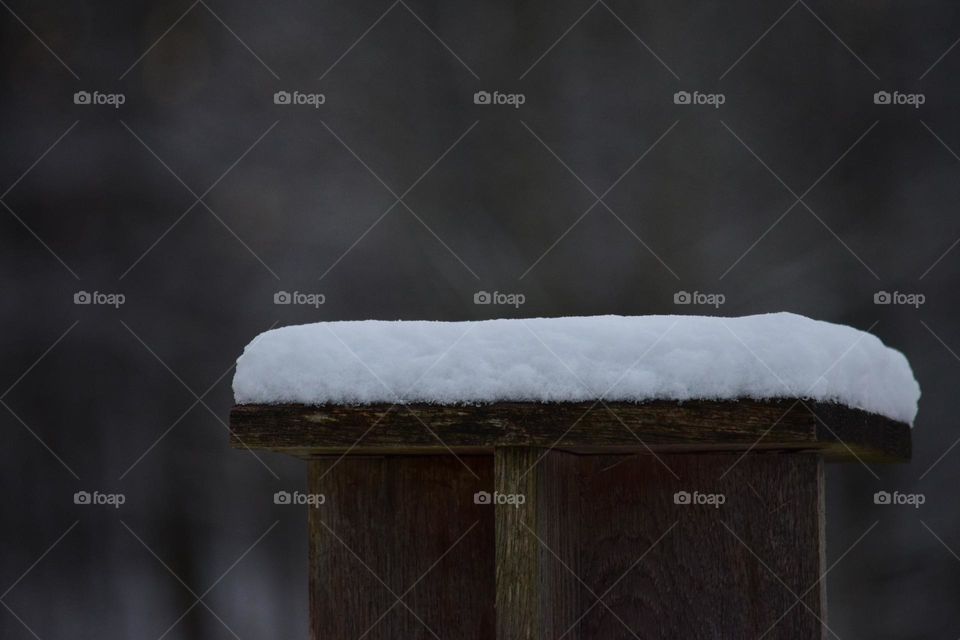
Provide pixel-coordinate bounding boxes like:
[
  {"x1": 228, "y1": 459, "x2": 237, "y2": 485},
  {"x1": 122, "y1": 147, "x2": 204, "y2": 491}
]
[{"x1": 230, "y1": 399, "x2": 911, "y2": 462}]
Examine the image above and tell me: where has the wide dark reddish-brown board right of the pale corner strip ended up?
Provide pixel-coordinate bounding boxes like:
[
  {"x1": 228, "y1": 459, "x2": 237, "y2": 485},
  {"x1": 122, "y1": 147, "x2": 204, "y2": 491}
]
[{"x1": 580, "y1": 454, "x2": 826, "y2": 640}]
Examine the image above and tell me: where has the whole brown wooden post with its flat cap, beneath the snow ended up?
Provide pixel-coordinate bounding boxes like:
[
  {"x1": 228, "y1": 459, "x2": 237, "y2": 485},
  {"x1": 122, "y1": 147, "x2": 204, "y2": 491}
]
[{"x1": 231, "y1": 400, "x2": 910, "y2": 640}]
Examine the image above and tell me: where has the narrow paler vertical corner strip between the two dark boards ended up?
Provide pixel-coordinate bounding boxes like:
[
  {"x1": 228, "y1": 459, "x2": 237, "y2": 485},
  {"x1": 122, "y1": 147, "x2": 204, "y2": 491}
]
[{"x1": 494, "y1": 447, "x2": 580, "y2": 640}]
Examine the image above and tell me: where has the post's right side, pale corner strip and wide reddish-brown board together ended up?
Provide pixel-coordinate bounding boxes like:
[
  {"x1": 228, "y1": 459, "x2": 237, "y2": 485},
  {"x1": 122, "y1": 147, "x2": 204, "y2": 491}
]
[{"x1": 495, "y1": 449, "x2": 826, "y2": 640}]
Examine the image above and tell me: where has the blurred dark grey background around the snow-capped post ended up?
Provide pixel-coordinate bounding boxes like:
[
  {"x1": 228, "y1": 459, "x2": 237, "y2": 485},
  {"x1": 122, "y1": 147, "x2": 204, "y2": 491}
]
[{"x1": 0, "y1": 0, "x2": 960, "y2": 639}]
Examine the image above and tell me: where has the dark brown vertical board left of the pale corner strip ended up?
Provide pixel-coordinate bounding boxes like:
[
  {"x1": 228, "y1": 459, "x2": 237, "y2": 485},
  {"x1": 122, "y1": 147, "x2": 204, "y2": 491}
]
[{"x1": 308, "y1": 455, "x2": 494, "y2": 640}]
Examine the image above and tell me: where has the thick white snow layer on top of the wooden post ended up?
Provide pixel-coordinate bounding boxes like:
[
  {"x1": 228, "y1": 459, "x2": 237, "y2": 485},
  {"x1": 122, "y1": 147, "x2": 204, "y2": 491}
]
[{"x1": 233, "y1": 313, "x2": 920, "y2": 424}]
